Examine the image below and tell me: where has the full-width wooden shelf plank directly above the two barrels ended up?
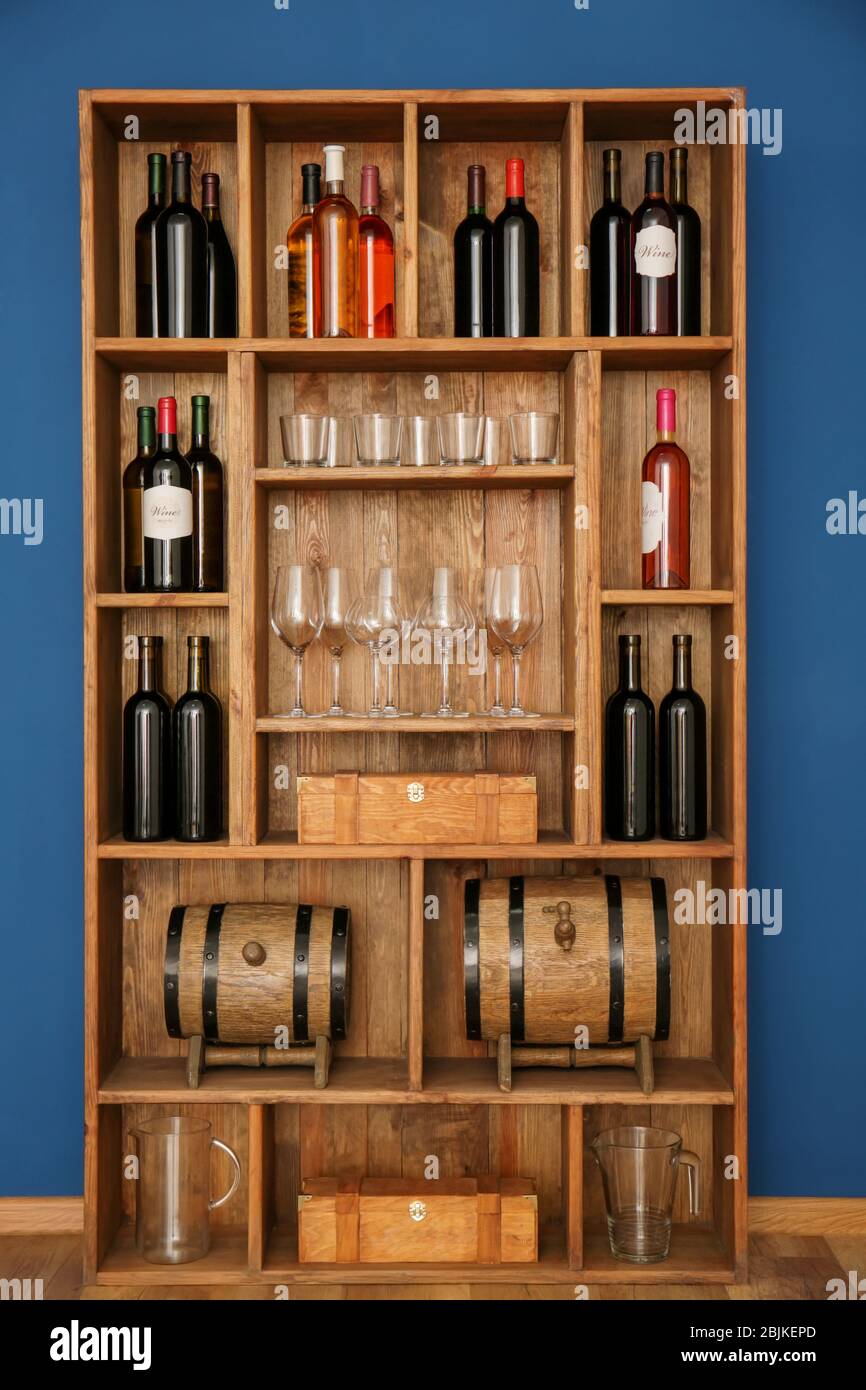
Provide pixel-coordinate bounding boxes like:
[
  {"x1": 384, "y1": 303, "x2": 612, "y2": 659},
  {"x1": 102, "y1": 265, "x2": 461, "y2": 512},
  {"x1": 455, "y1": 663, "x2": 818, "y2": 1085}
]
[{"x1": 99, "y1": 830, "x2": 737, "y2": 859}]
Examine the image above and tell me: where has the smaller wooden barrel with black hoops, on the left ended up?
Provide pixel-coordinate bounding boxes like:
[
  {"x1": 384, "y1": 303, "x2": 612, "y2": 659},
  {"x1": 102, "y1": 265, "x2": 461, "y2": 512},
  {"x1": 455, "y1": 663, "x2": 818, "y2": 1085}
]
[{"x1": 164, "y1": 902, "x2": 352, "y2": 1044}]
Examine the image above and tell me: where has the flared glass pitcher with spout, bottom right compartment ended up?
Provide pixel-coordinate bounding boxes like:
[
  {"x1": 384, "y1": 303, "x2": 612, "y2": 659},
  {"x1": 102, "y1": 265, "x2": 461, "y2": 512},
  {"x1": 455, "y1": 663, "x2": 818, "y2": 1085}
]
[{"x1": 591, "y1": 1125, "x2": 701, "y2": 1265}]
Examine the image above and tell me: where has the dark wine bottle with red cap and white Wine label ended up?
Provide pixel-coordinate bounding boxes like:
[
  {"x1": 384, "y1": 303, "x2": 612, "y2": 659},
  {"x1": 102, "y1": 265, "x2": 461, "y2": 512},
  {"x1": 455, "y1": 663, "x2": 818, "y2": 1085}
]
[{"x1": 142, "y1": 396, "x2": 192, "y2": 594}]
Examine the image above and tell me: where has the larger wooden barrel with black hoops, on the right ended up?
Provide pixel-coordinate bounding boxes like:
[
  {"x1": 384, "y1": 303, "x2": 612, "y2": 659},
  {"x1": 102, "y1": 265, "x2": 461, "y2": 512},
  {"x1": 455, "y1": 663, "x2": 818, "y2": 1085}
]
[{"x1": 463, "y1": 876, "x2": 670, "y2": 1044}]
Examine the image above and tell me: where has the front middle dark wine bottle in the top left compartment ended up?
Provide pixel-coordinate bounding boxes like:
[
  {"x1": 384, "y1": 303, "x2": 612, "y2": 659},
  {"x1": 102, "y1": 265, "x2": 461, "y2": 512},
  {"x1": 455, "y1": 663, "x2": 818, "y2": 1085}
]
[{"x1": 156, "y1": 150, "x2": 207, "y2": 338}]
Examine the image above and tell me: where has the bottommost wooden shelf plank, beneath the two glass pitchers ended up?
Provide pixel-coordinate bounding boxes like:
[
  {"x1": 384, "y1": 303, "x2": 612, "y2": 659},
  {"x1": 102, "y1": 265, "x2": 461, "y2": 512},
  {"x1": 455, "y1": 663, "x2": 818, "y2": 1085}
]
[{"x1": 96, "y1": 1225, "x2": 735, "y2": 1287}]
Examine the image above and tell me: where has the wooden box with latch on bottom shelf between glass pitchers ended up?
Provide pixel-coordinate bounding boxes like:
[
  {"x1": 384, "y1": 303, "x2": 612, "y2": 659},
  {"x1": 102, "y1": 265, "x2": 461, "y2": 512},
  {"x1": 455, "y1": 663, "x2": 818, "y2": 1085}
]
[{"x1": 297, "y1": 1177, "x2": 538, "y2": 1265}]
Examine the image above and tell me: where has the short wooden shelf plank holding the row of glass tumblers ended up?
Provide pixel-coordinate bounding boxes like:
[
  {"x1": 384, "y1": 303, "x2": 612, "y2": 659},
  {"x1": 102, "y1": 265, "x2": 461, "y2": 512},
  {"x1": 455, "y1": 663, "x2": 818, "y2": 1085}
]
[{"x1": 256, "y1": 463, "x2": 574, "y2": 491}]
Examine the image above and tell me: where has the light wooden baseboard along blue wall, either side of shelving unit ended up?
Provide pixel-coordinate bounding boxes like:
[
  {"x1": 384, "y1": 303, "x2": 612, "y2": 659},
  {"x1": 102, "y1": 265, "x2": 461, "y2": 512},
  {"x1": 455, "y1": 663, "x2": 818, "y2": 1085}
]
[{"x1": 0, "y1": 1197, "x2": 866, "y2": 1236}]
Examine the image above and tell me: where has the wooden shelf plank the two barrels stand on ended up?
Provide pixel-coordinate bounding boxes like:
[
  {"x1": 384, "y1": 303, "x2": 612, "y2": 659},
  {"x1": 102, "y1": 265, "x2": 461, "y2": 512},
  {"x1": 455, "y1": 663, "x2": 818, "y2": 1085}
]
[{"x1": 99, "y1": 1056, "x2": 734, "y2": 1105}]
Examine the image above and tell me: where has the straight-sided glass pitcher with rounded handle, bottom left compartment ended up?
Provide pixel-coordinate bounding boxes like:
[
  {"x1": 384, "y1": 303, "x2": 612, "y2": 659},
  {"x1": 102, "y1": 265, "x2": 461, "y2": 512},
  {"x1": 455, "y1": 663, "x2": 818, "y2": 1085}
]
[{"x1": 132, "y1": 1115, "x2": 240, "y2": 1265}]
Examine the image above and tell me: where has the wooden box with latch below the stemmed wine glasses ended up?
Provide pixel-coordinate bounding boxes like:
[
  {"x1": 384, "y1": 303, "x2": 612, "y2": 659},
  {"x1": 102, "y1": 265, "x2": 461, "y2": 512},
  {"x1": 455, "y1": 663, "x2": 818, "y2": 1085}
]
[{"x1": 297, "y1": 773, "x2": 538, "y2": 845}]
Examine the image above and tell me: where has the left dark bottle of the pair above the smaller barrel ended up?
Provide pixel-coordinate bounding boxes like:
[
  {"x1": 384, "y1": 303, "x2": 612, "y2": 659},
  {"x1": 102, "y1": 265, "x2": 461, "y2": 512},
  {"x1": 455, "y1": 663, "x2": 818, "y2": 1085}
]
[{"x1": 124, "y1": 637, "x2": 174, "y2": 840}]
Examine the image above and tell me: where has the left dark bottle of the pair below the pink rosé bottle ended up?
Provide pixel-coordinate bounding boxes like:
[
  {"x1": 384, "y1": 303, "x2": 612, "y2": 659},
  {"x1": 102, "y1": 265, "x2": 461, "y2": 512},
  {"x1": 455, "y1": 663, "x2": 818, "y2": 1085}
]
[{"x1": 605, "y1": 637, "x2": 656, "y2": 840}]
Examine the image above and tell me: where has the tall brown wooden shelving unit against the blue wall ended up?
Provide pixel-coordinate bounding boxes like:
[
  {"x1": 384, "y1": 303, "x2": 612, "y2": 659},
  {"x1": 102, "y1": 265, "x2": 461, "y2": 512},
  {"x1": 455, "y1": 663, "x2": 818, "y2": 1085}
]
[{"x1": 81, "y1": 89, "x2": 746, "y2": 1284}]
